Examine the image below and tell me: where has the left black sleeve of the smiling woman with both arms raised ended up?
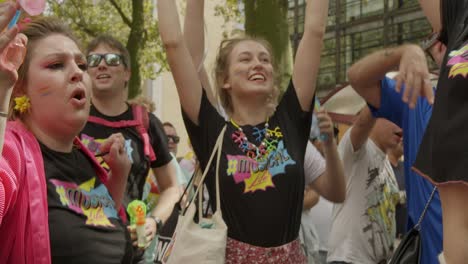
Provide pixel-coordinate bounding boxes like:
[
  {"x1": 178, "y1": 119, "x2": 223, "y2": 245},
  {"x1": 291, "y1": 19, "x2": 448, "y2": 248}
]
[{"x1": 182, "y1": 90, "x2": 225, "y2": 168}]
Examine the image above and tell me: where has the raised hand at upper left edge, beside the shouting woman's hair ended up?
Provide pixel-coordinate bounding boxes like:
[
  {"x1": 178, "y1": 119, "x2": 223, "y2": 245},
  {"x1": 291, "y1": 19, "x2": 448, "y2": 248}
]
[{"x1": 0, "y1": 2, "x2": 27, "y2": 89}]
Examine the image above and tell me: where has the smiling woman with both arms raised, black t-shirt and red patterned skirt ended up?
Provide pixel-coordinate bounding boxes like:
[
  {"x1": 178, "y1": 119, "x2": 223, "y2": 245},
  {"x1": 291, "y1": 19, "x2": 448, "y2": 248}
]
[{"x1": 158, "y1": 0, "x2": 328, "y2": 263}]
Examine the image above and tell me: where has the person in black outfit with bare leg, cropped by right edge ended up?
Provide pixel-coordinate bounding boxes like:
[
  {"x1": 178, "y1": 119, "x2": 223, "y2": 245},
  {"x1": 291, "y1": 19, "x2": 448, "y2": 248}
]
[{"x1": 414, "y1": 0, "x2": 468, "y2": 264}]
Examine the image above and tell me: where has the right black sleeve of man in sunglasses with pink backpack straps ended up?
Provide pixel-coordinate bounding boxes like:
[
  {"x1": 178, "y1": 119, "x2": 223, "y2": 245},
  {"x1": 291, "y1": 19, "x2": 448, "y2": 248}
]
[{"x1": 148, "y1": 113, "x2": 172, "y2": 168}]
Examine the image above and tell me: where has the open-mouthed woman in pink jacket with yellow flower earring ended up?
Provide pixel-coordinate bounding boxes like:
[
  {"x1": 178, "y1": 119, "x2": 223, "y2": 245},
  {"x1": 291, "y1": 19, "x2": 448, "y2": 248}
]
[{"x1": 0, "y1": 5, "x2": 132, "y2": 264}]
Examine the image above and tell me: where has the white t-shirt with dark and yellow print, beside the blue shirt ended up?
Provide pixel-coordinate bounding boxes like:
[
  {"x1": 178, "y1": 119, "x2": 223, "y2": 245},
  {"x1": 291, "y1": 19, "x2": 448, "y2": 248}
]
[{"x1": 327, "y1": 129, "x2": 398, "y2": 264}]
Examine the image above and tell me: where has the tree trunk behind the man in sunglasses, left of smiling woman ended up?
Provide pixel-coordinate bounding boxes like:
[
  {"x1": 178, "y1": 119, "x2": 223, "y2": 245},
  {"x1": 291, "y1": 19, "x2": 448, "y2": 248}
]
[{"x1": 127, "y1": 0, "x2": 145, "y2": 99}]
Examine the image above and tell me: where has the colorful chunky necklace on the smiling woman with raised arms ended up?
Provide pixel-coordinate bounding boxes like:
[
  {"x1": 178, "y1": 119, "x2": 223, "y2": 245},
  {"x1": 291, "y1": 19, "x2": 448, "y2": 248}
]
[{"x1": 230, "y1": 118, "x2": 270, "y2": 161}]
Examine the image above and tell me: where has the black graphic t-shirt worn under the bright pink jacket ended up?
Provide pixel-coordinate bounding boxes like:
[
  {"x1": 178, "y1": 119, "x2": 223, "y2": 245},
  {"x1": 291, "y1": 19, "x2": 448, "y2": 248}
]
[{"x1": 40, "y1": 144, "x2": 132, "y2": 264}]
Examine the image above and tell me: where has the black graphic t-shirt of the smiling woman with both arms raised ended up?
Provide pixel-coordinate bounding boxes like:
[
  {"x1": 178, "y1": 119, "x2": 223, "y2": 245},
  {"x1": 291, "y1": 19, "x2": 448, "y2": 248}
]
[{"x1": 184, "y1": 82, "x2": 312, "y2": 247}]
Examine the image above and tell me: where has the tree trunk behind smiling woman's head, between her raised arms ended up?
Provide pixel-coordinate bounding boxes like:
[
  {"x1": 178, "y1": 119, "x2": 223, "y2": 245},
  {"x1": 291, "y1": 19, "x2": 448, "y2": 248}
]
[{"x1": 244, "y1": 0, "x2": 293, "y2": 91}]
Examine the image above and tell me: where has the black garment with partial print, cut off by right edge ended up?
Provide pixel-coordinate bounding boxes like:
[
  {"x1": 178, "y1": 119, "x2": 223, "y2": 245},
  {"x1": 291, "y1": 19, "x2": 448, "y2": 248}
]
[{"x1": 414, "y1": 0, "x2": 468, "y2": 183}]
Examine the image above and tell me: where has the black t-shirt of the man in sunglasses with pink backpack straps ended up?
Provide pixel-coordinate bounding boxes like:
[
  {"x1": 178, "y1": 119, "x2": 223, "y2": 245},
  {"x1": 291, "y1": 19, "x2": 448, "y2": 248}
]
[{"x1": 80, "y1": 106, "x2": 172, "y2": 206}]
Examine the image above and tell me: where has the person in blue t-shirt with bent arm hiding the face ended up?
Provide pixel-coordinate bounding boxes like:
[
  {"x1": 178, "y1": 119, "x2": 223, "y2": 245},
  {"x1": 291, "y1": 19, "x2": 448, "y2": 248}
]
[{"x1": 348, "y1": 38, "x2": 446, "y2": 264}]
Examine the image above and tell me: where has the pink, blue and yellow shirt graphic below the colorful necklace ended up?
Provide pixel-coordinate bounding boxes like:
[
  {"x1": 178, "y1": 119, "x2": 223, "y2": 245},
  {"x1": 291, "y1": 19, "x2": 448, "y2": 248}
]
[{"x1": 227, "y1": 127, "x2": 296, "y2": 193}]
